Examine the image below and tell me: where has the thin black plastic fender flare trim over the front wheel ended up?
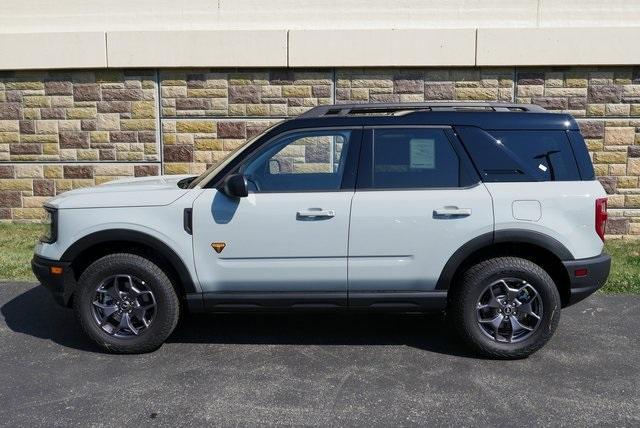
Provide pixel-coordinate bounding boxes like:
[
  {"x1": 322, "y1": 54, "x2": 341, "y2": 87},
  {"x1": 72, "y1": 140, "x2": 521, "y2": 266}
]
[{"x1": 60, "y1": 229, "x2": 197, "y2": 293}]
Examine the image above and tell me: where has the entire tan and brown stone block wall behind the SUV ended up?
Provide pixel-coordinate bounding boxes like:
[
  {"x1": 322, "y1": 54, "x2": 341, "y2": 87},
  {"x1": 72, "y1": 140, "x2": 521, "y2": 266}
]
[{"x1": 0, "y1": 66, "x2": 640, "y2": 237}]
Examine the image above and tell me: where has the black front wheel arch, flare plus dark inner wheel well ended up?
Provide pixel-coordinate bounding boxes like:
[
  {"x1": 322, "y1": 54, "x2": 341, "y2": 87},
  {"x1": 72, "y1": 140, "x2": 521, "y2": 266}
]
[{"x1": 61, "y1": 229, "x2": 197, "y2": 297}]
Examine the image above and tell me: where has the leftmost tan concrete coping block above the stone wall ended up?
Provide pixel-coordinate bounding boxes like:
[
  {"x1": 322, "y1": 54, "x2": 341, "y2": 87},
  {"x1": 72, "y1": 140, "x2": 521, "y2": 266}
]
[{"x1": 0, "y1": 32, "x2": 107, "y2": 70}]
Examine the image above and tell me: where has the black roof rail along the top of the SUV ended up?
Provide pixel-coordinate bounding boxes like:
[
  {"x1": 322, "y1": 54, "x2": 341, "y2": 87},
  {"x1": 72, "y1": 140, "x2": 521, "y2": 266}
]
[{"x1": 298, "y1": 101, "x2": 547, "y2": 118}]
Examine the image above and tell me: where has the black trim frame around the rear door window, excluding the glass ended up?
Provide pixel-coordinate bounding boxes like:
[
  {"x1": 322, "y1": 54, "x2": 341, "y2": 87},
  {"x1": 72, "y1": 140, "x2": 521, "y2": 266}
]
[{"x1": 356, "y1": 125, "x2": 482, "y2": 192}]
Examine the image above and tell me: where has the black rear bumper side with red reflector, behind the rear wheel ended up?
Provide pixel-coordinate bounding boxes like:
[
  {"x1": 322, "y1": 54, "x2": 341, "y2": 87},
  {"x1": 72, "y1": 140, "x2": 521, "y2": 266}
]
[{"x1": 562, "y1": 253, "x2": 611, "y2": 306}]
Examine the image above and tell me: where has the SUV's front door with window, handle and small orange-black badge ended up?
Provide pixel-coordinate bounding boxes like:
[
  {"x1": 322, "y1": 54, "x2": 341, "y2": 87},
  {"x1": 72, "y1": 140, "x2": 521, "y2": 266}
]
[{"x1": 193, "y1": 129, "x2": 362, "y2": 302}]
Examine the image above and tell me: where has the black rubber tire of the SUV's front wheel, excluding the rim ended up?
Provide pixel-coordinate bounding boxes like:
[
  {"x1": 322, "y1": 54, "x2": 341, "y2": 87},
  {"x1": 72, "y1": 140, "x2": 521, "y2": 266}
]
[{"x1": 74, "y1": 254, "x2": 178, "y2": 352}]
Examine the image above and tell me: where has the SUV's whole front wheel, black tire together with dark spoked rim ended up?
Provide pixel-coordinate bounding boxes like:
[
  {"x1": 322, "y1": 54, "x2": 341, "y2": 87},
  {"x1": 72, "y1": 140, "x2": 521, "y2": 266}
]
[{"x1": 73, "y1": 253, "x2": 180, "y2": 354}]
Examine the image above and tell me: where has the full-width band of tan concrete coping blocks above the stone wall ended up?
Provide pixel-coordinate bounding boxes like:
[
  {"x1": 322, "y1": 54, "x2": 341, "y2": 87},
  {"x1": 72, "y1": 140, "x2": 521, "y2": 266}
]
[{"x1": 0, "y1": 27, "x2": 640, "y2": 70}]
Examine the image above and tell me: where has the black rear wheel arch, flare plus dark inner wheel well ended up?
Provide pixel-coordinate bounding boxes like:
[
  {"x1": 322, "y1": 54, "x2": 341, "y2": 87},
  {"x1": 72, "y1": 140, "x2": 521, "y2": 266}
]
[{"x1": 436, "y1": 229, "x2": 574, "y2": 306}]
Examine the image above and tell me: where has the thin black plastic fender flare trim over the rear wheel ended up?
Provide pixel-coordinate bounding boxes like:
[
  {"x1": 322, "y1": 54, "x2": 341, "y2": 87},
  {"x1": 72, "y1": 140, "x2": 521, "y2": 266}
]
[{"x1": 435, "y1": 229, "x2": 575, "y2": 290}]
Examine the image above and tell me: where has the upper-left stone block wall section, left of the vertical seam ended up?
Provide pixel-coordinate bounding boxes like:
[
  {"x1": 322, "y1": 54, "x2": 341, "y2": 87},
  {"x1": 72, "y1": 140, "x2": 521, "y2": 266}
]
[{"x1": 0, "y1": 71, "x2": 159, "y2": 162}]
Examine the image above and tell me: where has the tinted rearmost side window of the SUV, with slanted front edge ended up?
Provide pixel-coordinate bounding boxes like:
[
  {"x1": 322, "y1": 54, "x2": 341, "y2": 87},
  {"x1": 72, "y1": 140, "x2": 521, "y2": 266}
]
[{"x1": 488, "y1": 131, "x2": 580, "y2": 181}]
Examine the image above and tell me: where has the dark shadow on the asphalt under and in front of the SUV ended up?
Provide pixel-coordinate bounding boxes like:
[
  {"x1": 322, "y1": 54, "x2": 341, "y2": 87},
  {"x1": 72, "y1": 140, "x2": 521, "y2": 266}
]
[{"x1": 0, "y1": 286, "x2": 475, "y2": 357}]
